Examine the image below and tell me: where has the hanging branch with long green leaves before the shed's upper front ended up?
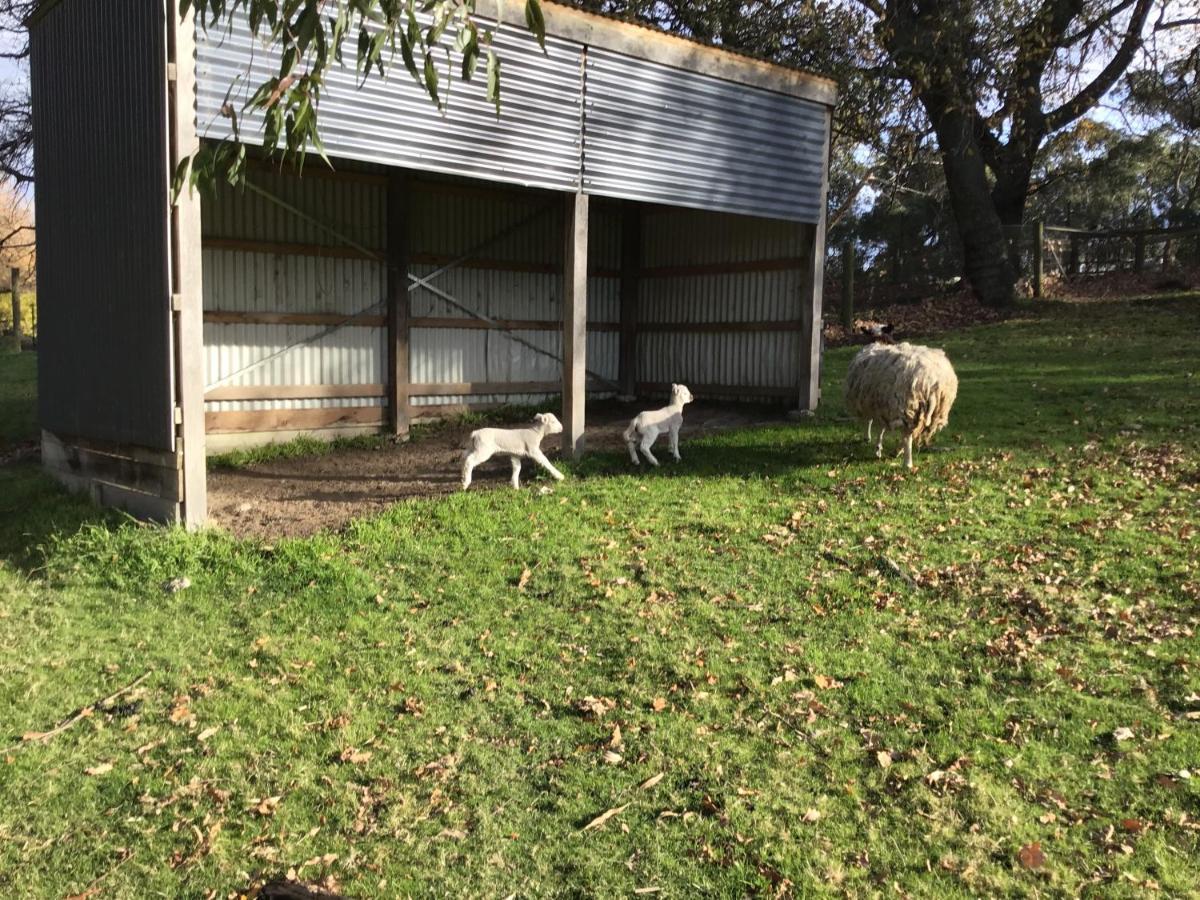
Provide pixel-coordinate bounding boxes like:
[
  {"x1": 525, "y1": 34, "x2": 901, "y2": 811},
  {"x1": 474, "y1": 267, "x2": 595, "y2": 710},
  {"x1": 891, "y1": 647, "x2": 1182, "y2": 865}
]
[{"x1": 174, "y1": 0, "x2": 546, "y2": 193}]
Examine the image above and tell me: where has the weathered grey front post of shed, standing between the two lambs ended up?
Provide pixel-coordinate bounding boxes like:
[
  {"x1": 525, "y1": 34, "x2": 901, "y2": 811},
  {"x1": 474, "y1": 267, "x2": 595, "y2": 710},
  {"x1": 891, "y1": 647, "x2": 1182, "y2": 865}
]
[{"x1": 563, "y1": 193, "x2": 588, "y2": 458}]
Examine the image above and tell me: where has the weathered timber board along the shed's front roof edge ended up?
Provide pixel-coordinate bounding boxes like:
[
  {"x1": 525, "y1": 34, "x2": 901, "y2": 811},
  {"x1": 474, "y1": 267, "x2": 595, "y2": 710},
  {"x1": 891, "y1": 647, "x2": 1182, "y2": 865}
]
[{"x1": 476, "y1": 0, "x2": 838, "y2": 107}]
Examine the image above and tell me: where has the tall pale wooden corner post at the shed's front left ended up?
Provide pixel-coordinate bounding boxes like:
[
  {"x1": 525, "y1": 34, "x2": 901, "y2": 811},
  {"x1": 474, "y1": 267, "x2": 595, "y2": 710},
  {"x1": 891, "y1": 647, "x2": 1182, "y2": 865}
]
[{"x1": 167, "y1": 2, "x2": 208, "y2": 529}]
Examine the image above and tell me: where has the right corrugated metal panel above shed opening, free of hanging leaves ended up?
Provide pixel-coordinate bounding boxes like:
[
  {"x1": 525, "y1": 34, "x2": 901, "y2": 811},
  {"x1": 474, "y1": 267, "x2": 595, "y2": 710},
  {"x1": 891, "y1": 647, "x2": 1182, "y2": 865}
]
[{"x1": 583, "y1": 48, "x2": 828, "y2": 222}]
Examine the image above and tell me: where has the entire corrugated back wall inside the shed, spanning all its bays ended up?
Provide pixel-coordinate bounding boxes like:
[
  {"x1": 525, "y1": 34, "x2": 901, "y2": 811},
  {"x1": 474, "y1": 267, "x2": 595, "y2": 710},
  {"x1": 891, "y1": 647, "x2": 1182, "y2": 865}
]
[{"x1": 204, "y1": 168, "x2": 620, "y2": 439}]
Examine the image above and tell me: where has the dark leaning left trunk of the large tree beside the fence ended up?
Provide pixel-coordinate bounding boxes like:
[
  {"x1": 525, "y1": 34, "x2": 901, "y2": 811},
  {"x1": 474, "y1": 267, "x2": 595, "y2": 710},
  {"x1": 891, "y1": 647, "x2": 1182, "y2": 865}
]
[{"x1": 922, "y1": 104, "x2": 1016, "y2": 306}]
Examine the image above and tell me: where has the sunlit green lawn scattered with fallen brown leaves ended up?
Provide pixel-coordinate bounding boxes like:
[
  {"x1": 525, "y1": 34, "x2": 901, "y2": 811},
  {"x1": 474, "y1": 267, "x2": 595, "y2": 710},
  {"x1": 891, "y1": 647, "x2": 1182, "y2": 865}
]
[{"x1": 0, "y1": 296, "x2": 1200, "y2": 898}]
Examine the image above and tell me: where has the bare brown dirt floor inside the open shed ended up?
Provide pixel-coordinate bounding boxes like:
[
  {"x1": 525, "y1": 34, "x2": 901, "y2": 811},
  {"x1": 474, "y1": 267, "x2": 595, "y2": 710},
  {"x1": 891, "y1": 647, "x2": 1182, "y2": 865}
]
[{"x1": 209, "y1": 402, "x2": 787, "y2": 539}]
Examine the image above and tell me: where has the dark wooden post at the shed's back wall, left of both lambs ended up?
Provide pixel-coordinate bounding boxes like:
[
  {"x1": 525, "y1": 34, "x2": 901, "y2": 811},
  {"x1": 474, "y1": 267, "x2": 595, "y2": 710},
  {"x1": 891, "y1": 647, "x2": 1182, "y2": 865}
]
[{"x1": 386, "y1": 170, "x2": 412, "y2": 437}]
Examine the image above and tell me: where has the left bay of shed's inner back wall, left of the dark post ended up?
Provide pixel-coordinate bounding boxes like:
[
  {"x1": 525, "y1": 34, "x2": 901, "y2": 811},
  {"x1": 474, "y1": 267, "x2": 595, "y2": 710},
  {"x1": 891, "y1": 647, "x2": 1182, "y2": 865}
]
[{"x1": 203, "y1": 169, "x2": 386, "y2": 415}]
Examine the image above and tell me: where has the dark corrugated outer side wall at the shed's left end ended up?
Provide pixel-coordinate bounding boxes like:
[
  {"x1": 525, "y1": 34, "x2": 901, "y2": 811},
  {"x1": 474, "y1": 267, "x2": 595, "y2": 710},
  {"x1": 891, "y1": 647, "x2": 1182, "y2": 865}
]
[{"x1": 30, "y1": 0, "x2": 174, "y2": 450}]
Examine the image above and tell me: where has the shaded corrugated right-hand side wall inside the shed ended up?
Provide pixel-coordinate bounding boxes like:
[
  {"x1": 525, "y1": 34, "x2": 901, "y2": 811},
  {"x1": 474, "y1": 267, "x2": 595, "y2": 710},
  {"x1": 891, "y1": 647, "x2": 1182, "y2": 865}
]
[{"x1": 637, "y1": 208, "x2": 806, "y2": 400}]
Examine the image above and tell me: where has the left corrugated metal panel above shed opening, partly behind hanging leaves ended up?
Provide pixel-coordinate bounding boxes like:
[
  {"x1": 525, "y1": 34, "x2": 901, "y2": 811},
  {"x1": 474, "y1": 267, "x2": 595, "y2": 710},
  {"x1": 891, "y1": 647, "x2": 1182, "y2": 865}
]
[{"x1": 197, "y1": 13, "x2": 583, "y2": 190}]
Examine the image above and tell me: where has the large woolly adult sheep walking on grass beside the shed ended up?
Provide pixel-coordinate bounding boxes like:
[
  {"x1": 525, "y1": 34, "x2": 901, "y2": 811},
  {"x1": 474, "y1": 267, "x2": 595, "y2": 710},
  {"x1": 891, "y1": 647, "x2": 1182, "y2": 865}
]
[{"x1": 846, "y1": 343, "x2": 959, "y2": 469}]
